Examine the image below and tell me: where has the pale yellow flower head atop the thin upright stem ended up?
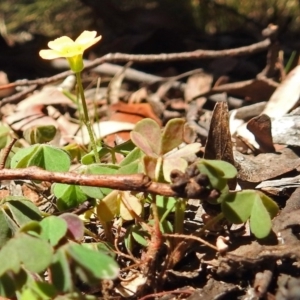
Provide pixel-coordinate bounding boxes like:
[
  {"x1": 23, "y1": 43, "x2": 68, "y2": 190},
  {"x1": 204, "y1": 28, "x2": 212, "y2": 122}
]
[{"x1": 40, "y1": 30, "x2": 101, "y2": 73}]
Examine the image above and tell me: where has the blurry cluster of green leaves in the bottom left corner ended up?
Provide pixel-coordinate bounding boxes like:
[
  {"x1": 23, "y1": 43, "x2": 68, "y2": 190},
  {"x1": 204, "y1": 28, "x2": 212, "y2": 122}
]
[{"x1": 0, "y1": 212, "x2": 119, "y2": 299}]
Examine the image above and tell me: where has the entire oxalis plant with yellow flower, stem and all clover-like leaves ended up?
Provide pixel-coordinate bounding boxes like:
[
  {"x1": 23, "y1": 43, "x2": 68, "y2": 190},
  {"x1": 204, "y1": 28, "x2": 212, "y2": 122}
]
[{"x1": 0, "y1": 31, "x2": 278, "y2": 300}]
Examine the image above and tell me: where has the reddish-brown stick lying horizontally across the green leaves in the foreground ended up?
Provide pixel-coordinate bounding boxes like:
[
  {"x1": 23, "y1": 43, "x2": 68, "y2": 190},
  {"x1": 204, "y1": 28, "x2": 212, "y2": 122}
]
[{"x1": 0, "y1": 167, "x2": 179, "y2": 197}]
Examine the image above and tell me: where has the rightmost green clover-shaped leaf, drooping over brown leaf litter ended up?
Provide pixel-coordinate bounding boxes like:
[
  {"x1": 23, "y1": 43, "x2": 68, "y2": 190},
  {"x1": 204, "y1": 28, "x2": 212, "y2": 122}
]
[{"x1": 221, "y1": 190, "x2": 279, "y2": 238}]
